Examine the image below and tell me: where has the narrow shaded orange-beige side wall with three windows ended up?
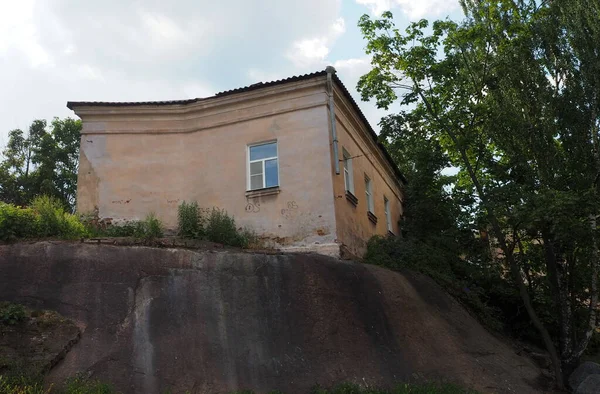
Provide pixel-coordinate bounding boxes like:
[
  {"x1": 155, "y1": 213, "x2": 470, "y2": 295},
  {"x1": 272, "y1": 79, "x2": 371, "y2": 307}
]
[{"x1": 332, "y1": 89, "x2": 403, "y2": 256}]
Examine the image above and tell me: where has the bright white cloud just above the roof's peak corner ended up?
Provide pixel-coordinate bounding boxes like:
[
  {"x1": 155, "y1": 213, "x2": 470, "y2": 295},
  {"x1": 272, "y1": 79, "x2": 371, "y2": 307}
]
[{"x1": 287, "y1": 18, "x2": 346, "y2": 68}]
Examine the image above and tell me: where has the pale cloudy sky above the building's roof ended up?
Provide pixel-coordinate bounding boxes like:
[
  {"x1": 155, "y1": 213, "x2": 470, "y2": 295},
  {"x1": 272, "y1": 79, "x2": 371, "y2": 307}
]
[{"x1": 0, "y1": 0, "x2": 460, "y2": 146}]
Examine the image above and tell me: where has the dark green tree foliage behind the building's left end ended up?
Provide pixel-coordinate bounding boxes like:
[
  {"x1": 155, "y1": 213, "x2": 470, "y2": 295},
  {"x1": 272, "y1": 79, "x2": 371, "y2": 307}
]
[{"x1": 0, "y1": 118, "x2": 81, "y2": 212}]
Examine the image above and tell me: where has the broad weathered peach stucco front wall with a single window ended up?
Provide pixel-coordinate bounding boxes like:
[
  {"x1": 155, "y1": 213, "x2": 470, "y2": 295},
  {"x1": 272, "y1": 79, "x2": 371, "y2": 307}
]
[{"x1": 76, "y1": 78, "x2": 336, "y2": 251}]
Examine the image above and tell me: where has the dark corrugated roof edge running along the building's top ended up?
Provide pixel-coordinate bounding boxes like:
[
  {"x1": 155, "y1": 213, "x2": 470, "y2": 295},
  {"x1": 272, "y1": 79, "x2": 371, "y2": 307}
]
[{"x1": 67, "y1": 70, "x2": 408, "y2": 184}]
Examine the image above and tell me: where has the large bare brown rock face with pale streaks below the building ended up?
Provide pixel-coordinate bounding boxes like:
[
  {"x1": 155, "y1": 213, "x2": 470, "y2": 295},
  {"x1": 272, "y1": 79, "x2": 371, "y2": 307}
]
[{"x1": 0, "y1": 242, "x2": 542, "y2": 393}]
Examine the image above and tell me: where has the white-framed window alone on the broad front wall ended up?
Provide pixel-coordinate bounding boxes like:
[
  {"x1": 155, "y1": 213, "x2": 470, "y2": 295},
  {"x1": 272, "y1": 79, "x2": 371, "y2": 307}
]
[{"x1": 247, "y1": 141, "x2": 279, "y2": 190}]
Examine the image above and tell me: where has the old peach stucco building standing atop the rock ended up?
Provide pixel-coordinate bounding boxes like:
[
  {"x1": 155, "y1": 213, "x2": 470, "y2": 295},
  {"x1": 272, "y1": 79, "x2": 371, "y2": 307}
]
[{"x1": 67, "y1": 67, "x2": 406, "y2": 256}]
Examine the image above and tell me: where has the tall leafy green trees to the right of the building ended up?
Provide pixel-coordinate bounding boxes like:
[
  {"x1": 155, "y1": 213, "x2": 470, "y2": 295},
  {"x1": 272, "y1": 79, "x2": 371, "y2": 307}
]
[{"x1": 359, "y1": 0, "x2": 600, "y2": 386}]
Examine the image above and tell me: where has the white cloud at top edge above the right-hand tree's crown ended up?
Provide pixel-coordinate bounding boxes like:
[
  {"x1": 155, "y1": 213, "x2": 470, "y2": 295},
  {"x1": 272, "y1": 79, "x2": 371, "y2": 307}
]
[{"x1": 356, "y1": 0, "x2": 459, "y2": 20}]
